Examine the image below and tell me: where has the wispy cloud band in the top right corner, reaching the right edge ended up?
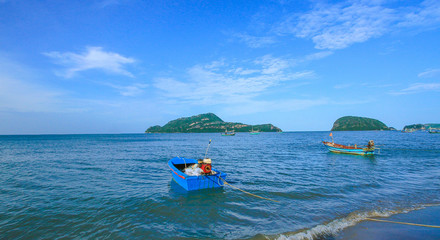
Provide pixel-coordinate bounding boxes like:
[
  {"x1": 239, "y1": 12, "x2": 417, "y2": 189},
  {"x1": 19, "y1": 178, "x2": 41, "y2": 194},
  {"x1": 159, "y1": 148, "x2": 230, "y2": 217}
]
[{"x1": 276, "y1": 0, "x2": 440, "y2": 49}]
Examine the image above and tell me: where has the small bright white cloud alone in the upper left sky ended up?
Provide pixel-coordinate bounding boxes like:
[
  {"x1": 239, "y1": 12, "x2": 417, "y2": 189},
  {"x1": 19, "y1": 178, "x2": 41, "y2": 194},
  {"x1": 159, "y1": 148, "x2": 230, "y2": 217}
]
[{"x1": 43, "y1": 47, "x2": 135, "y2": 78}]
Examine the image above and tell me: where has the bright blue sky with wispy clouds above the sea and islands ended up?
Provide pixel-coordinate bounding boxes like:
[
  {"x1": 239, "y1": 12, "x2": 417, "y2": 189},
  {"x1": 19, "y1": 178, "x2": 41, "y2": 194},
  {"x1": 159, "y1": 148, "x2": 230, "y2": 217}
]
[{"x1": 0, "y1": 0, "x2": 440, "y2": 134}]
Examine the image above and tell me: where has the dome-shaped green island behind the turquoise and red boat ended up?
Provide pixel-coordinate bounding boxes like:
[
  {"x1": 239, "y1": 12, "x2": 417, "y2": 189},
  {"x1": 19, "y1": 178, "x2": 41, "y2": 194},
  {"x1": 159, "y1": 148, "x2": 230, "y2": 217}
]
[{"x1": 331, "y1": 116, "x2": 393, "y2": 131}]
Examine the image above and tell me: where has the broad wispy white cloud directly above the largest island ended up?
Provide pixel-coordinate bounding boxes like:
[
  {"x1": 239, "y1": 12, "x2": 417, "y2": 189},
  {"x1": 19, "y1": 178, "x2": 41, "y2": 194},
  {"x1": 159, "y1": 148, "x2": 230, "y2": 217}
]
[{"x1": 154, "y1": 55, "x2": 314, "y2": 105}]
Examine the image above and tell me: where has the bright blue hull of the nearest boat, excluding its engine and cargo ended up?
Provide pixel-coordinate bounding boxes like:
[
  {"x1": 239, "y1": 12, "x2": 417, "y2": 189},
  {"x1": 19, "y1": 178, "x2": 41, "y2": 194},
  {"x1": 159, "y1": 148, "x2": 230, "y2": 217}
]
[{"x1": 168, "y1": 157, "x2": 227, "y2": 191}]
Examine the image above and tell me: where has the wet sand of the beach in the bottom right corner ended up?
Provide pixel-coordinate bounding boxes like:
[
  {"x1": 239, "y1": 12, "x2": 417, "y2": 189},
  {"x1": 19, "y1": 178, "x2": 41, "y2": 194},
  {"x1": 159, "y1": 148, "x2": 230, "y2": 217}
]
[{"x1": 335, "y1": 206, "x2": 440, "y2": 240}]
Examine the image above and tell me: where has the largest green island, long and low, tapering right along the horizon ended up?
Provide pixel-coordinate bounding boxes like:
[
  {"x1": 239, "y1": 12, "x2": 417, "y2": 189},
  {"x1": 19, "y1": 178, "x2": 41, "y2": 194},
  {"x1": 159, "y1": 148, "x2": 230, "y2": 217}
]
[{"x1": 145, "y1": 113, "x2": 281, "y2": 133}]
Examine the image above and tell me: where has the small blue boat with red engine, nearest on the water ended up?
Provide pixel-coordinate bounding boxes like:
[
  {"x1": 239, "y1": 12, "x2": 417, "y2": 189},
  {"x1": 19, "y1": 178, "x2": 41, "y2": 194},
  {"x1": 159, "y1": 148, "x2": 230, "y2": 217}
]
[{"x1": 168, "y1": 157, "x2": 227, "y2": 191}]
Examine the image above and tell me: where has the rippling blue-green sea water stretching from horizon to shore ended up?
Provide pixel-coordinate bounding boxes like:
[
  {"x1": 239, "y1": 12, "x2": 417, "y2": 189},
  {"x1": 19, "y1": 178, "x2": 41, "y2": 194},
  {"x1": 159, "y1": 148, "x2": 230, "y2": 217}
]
[{"x1": 0, "y1": 131, "x2": 440, "y2": 239}]
